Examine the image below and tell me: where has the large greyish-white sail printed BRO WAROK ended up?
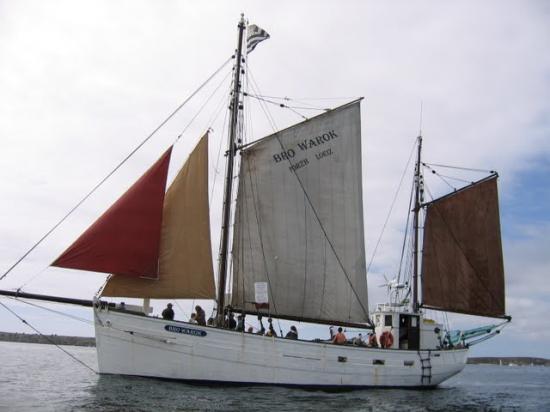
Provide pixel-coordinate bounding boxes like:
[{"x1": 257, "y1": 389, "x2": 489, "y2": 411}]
[{"x1": 231, "y1": 101, "x2": 368, "y2": 324}]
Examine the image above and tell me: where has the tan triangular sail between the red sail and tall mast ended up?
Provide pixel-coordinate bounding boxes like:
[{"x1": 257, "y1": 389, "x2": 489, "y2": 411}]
[{"x1": 102, "y1": 134, "x2": 215, "y2": 299}]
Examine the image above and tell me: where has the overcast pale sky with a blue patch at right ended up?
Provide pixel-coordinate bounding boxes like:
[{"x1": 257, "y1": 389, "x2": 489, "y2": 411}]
[{"x1": 0, "y1": 0, "x2": 550, "y2": 358}]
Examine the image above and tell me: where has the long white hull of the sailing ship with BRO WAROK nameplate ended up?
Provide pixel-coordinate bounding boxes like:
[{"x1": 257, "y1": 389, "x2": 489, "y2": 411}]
[{"x1": 95, "y1": 309, "x2": 468, "y2": 387}]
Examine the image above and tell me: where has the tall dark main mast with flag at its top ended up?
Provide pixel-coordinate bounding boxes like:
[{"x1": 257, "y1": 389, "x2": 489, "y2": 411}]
[{"x1": 217, "y1": 14, "x2": 245, "y2": 324}]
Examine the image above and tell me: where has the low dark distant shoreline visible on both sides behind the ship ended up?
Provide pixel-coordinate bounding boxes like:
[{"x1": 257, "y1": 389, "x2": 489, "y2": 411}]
[{"x1": 0, "y1": 332, "x2": 550, "y2": 366}]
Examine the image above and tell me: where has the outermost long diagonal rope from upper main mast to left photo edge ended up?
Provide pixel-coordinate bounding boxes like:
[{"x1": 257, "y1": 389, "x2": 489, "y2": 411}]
[{"x1": 0, "y1": 57, "x2": 233, "y2": 280}]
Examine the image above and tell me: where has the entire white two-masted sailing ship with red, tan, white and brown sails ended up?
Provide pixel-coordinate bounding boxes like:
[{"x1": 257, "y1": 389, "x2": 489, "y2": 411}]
[{"x1": 0, "y1": 18, "x2": 510, "y2": 388}]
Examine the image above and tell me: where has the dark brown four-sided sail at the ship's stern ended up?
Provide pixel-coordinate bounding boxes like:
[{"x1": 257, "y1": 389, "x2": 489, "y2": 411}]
[{"x1": 422, "y1": 175, "x2": 505, "y2": 317}]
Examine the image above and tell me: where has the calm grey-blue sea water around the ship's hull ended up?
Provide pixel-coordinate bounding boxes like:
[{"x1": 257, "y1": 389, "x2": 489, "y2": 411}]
[{"x1": 0, "y1": 342, "x2": 550, "y2": 411}]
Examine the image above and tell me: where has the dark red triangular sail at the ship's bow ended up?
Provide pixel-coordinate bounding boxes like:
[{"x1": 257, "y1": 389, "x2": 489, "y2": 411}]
[{"x1": 52, "y1": 147, "x2": 172, "y2": 277}]
